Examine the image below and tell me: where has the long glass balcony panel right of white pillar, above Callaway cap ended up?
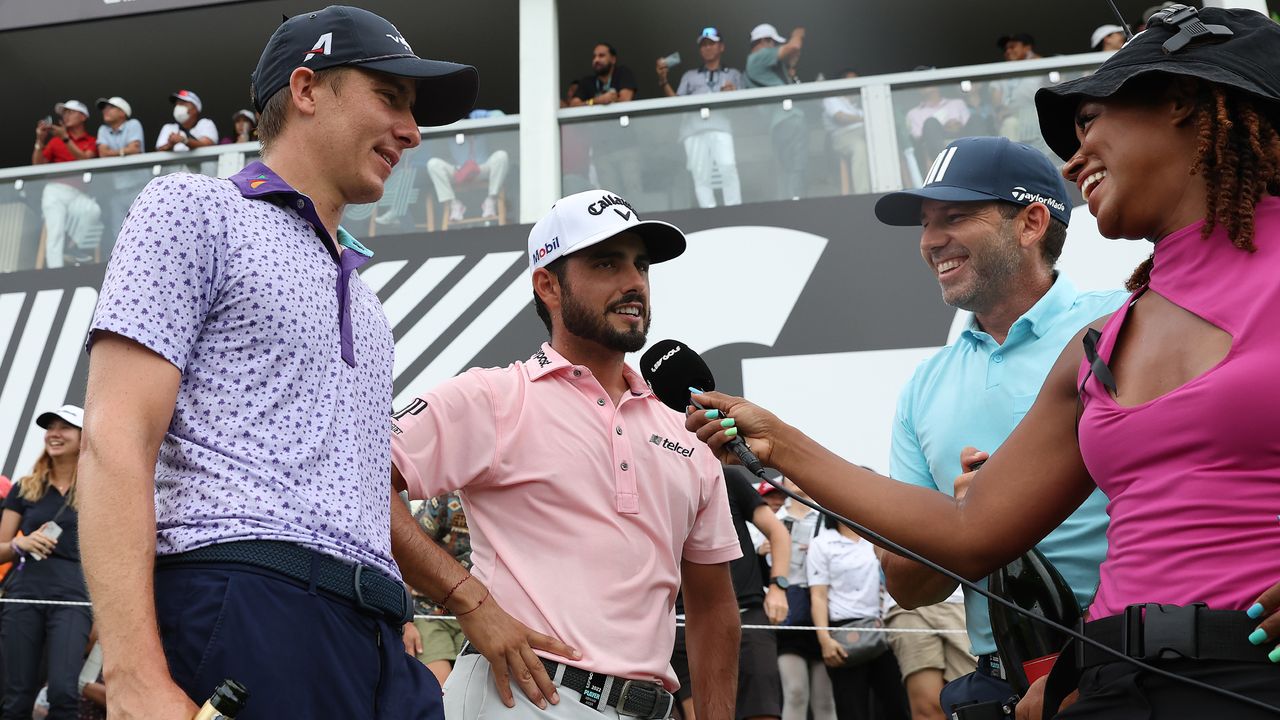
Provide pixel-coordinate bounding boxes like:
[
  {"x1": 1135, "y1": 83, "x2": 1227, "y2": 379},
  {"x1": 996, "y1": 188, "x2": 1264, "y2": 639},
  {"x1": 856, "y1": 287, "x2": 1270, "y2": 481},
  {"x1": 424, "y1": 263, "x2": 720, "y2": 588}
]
[{"x1": 561, "y1": 90, "x2": 870, "y2": 211}]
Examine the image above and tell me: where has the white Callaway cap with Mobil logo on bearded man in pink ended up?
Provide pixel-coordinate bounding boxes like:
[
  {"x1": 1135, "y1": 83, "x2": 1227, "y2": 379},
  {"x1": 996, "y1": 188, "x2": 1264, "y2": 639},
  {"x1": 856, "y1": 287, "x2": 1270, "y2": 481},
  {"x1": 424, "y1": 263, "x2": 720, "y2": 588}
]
[{"x1": 529, "y1": 190, "x2": 685, "y2": 269}]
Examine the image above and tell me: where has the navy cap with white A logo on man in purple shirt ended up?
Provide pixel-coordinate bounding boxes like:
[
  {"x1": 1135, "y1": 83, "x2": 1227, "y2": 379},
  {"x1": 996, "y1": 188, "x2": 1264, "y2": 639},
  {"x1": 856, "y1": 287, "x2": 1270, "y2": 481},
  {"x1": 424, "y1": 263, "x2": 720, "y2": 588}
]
[{"x1": 250, "y1": 5, "x2": 480, "y2": 126}]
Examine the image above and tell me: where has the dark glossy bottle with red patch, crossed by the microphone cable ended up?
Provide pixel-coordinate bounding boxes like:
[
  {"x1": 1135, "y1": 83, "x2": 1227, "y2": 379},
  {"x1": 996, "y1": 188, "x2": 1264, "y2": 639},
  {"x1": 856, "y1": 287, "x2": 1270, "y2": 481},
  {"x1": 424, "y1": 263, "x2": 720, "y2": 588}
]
[{"x1": 987, "y1": 547, "x2": 1080, "y2": 696}]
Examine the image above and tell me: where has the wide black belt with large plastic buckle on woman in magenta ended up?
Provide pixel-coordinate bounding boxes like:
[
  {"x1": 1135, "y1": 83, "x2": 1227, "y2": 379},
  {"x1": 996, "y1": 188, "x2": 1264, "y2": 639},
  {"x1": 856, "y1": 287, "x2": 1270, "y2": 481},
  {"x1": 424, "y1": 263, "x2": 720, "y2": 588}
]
[{"x1": 1075, "y1": 602, "x2": 1270, "y2": 670}]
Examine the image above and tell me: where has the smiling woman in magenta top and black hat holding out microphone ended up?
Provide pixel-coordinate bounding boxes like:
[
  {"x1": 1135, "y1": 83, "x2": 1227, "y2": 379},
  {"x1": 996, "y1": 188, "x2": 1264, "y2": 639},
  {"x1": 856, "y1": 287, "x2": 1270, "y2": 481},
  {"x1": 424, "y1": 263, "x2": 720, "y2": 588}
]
[{"x1": 689, "y1": 5, "x2": 1280, "y2": 719}]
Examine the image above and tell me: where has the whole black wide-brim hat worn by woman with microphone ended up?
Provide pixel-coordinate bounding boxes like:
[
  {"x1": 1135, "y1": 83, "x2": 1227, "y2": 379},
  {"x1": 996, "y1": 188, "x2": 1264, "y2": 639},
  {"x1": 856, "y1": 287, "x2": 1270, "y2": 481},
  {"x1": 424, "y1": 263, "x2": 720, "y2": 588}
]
[{"x1": 1036, "y1": 5, "x2": 1280, "y2": 160}]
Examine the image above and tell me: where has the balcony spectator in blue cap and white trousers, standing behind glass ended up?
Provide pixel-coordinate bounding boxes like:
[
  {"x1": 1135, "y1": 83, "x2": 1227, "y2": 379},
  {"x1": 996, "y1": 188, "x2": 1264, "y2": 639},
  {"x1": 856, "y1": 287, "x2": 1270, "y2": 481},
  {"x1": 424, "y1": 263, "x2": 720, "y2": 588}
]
[{"x1": 658, "y1": 27, "x2": 742, "y2": 208}]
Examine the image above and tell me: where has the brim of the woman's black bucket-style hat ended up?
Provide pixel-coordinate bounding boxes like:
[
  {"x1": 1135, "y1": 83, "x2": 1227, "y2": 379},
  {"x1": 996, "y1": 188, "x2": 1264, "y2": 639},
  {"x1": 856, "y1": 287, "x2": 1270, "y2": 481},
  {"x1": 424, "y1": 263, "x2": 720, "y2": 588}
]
[{"x1": 1036, "y1": 59, "x2": 1280, "y2": 160}]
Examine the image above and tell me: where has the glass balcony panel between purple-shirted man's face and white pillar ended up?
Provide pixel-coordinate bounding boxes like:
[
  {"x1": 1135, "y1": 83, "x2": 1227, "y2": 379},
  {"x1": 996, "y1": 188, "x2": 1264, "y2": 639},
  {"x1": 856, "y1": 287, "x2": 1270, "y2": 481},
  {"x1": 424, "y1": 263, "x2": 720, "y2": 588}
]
[{"x1": 342, "y1": 127, "x2": 520, "y2": 237}]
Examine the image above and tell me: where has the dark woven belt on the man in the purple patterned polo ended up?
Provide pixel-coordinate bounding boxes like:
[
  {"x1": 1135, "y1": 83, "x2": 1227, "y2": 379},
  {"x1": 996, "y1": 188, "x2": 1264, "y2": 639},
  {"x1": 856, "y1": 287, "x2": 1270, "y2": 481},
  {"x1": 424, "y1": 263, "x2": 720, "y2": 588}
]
[{"x1": 156, "y1": 541, "x2": 413, "y2": 625}]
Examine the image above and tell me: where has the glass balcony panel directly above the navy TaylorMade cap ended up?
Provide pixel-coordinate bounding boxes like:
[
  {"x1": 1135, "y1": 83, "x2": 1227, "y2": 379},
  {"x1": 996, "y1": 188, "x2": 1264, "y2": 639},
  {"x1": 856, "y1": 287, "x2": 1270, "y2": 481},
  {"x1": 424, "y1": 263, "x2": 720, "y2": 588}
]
[{"x1": 892, "y1": 69, "x2": 1089, "y2": 187}]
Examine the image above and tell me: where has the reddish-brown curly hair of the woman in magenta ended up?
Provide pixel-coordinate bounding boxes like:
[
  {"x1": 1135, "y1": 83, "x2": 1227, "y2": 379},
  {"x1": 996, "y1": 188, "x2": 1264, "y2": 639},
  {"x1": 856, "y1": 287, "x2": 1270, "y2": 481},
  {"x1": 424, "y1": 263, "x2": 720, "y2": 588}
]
[{"x1": 1125, "y1": 83, "x2": 1280, "y2": 292}]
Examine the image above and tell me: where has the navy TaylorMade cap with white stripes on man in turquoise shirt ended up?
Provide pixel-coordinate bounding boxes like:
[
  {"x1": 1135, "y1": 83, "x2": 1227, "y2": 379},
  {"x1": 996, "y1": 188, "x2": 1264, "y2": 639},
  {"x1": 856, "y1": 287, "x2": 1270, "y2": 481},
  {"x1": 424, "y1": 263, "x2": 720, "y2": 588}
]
[{"x1": 876, "y1": 137, "x2": 1071, "y2": 225}]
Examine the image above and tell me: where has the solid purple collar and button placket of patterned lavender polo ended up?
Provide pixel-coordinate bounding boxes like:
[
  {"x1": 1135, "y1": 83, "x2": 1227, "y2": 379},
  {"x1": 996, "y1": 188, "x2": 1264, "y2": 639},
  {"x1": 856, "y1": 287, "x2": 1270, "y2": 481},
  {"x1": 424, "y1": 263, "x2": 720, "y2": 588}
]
[{"x1": 230, "y1": 160, "x2": 374, "y2": 368}]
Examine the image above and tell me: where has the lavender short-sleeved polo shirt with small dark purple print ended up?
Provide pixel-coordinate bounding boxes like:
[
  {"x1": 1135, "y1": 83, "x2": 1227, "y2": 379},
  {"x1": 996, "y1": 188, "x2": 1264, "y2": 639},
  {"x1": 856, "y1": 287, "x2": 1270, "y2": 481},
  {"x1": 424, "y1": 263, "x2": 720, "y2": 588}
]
[{"x1": 88, "y1": 163, "x2": 399, "y2": 578}]
